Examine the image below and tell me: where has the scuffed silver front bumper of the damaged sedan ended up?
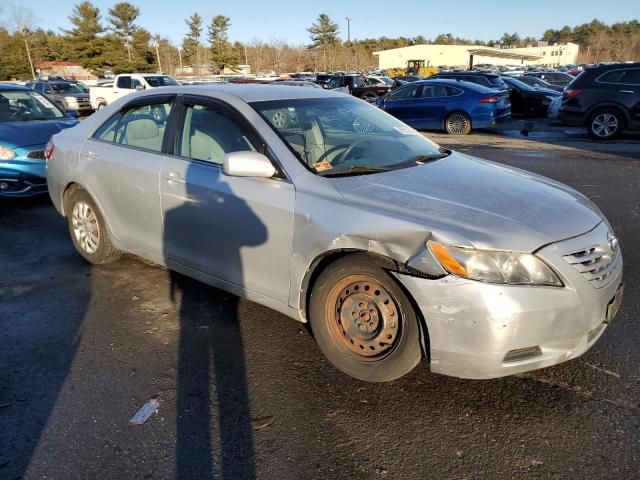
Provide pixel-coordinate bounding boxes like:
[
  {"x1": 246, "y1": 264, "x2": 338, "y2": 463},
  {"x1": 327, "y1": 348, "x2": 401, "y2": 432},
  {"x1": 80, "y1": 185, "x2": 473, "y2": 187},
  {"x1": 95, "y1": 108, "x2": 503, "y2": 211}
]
[{"x1": 396, "y1": 222, "x2": 622, "y2": 379}]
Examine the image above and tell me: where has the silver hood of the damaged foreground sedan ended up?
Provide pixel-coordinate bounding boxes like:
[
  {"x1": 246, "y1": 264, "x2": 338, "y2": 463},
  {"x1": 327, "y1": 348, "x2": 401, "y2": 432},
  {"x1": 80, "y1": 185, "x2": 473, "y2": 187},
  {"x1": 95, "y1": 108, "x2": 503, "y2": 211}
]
[{"x1": 332, "y1": 152, "x2": 603, "y2": 252}]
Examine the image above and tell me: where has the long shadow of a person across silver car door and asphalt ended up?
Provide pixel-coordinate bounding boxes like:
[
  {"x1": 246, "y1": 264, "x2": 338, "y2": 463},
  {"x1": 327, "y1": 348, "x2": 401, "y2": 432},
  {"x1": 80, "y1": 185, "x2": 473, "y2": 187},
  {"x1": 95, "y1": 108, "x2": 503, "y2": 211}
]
[{"x1": 164, "y1": 163, "x2": 267, "y2": 480}]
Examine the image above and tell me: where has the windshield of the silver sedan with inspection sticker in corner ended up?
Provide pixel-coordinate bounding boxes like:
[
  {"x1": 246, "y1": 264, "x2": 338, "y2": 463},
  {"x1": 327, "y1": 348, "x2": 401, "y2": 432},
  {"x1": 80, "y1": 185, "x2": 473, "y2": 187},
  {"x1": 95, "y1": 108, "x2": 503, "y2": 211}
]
[{"x1": 251, "y1": 97, "x2": 444, "y2": 175}]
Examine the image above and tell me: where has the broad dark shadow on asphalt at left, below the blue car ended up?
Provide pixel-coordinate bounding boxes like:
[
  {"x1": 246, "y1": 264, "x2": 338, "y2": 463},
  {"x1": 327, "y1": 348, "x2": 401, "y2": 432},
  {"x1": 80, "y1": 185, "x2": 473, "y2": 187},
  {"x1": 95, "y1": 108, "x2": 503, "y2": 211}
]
[{"x1": 0, "y1": 196, "x2": 93, "y2": 478}]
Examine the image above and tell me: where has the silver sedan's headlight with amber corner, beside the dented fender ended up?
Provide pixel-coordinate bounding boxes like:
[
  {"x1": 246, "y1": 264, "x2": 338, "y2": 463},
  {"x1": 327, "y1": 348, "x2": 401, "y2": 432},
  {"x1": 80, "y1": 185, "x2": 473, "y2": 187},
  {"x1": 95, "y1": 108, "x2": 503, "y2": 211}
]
[{"x1": 427, "y1": 241, "x2": 564, "y2": 287}]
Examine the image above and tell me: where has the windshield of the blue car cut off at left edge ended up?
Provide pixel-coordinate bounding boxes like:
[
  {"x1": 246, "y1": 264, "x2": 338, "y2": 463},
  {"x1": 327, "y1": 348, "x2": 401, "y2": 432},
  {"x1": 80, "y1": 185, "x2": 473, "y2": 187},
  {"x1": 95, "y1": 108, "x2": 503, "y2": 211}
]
[{"x1": 0, "y1": 90, "x2": 65, "y2": 122}]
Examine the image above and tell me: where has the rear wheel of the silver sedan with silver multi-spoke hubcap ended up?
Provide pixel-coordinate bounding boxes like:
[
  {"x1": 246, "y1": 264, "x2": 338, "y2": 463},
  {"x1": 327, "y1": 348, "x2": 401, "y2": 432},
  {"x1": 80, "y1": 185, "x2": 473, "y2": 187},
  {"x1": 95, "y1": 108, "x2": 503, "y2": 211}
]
[{"x1": 65, "y1": 188, "x2": 121, "y2": 265}]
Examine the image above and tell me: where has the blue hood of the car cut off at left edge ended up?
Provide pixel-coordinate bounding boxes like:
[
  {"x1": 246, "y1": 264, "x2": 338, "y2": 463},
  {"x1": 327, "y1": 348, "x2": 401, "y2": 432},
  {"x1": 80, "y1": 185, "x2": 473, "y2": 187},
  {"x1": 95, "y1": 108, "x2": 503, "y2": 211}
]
[{"x1": 0, "y1": 117, "x2": 78, "y2": 148}]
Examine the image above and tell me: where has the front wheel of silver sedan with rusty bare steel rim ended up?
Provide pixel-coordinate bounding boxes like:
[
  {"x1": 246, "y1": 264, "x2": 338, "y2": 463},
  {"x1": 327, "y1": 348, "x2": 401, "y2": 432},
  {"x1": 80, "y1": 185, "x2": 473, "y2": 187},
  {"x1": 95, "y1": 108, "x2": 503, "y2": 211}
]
[{"x1": 309, "y1": 254, "x2": 422, "y2": 382}]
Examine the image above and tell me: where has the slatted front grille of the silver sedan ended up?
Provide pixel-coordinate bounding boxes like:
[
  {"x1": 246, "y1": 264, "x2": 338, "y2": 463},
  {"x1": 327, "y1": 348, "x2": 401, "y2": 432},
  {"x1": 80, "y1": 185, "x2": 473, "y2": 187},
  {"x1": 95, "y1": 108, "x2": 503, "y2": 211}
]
[{"x1": 563, "y1": 245, "x2": 621, "y2": 288}]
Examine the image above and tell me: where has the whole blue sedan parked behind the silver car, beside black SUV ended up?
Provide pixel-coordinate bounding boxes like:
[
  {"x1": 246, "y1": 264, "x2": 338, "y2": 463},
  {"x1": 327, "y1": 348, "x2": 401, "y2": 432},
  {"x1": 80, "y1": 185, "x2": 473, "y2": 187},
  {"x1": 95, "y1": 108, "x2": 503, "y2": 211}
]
[{"x1": 376, "y1": 79, "x2": 511, "y2": 135}]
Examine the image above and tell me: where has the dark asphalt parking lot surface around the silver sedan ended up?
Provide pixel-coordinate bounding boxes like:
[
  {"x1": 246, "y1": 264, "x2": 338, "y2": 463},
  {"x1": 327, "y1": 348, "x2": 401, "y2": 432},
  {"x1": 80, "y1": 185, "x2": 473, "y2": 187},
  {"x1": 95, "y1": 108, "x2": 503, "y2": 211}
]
[{"x1": 0, "y1": 128, "x2": 640, "y2": 479}]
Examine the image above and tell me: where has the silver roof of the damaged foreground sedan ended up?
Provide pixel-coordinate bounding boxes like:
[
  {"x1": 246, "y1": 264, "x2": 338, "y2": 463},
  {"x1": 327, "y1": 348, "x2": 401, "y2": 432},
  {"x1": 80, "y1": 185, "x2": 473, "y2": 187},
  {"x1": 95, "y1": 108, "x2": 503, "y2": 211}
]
[{"x1": 135, "y1": 83, "x2": 351, "y2": 103}]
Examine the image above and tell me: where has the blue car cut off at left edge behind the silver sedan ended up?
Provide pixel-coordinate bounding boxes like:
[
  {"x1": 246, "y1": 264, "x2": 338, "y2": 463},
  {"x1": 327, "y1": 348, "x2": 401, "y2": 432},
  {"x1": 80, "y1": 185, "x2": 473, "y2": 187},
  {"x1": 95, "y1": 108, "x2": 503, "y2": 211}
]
[{"x1": 0, "y1": 84, "x2": 78, "y2": 197}]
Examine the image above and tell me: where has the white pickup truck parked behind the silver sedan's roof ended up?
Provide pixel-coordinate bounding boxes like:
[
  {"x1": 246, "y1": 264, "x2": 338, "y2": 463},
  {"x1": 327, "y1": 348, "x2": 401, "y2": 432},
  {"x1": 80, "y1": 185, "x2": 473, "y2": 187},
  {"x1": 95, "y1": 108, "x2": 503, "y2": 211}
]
[{"x1": 89, "y1": 73, "x2": 178, "y2": 110}]
